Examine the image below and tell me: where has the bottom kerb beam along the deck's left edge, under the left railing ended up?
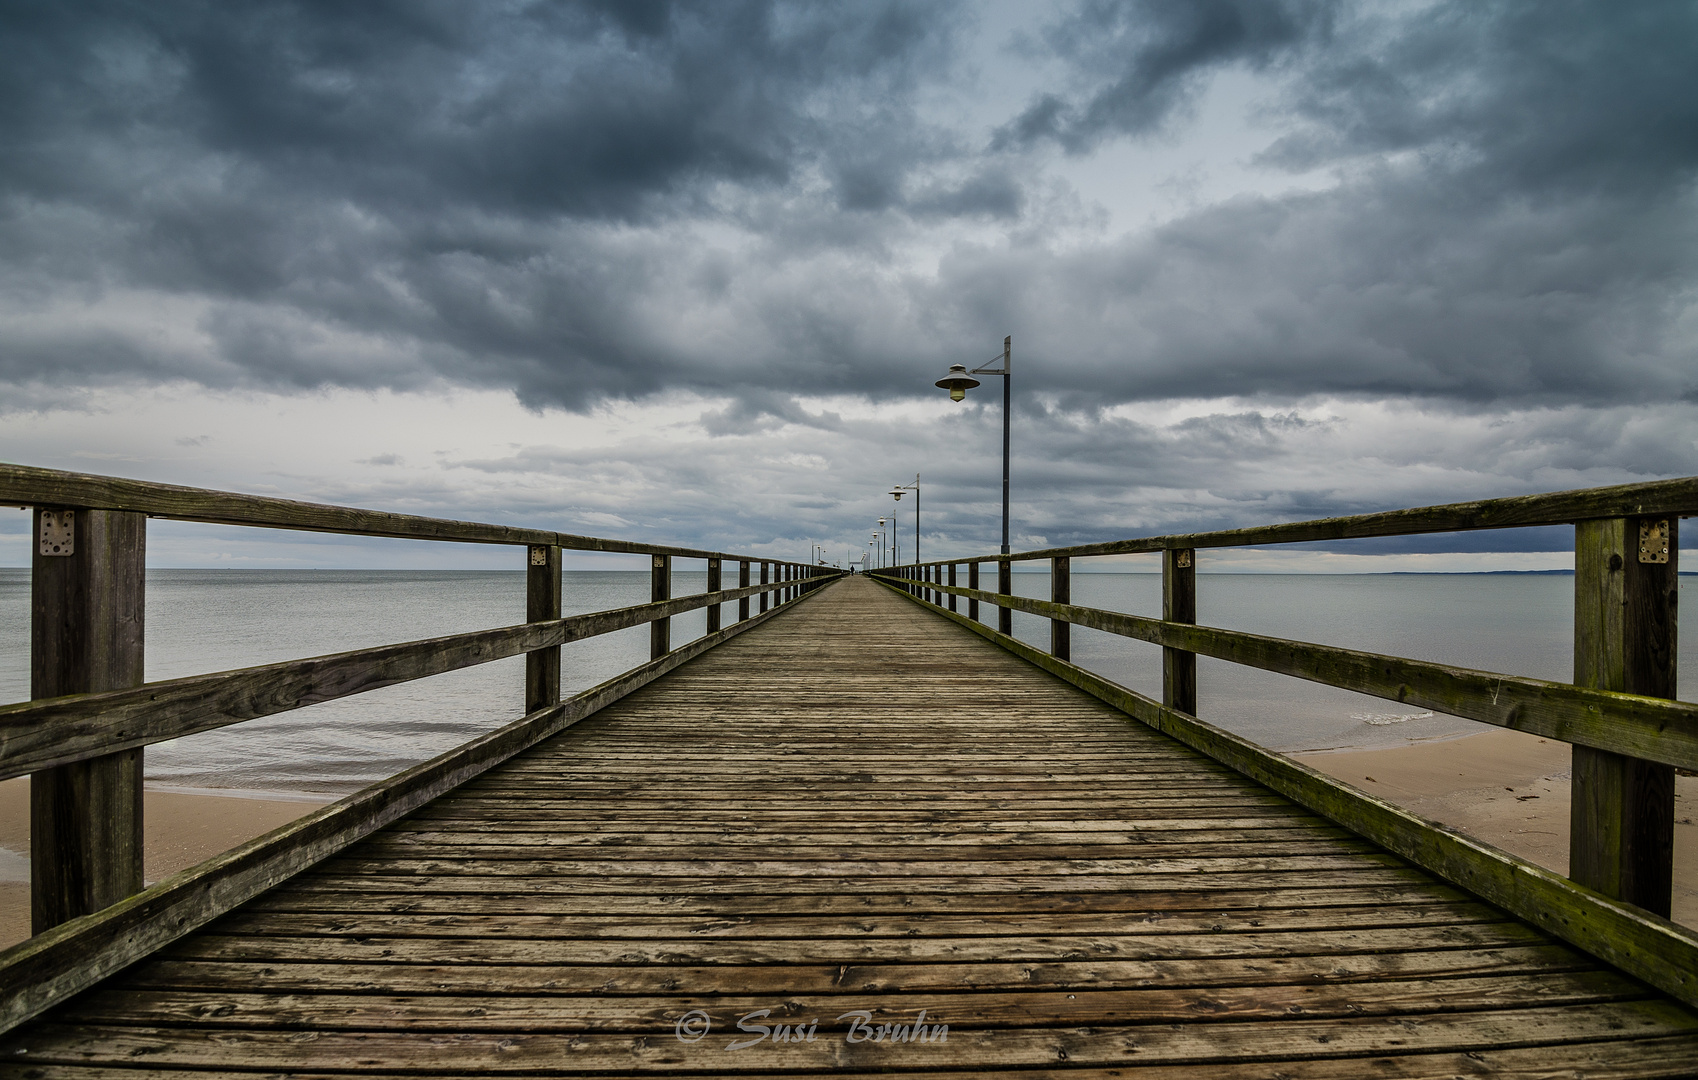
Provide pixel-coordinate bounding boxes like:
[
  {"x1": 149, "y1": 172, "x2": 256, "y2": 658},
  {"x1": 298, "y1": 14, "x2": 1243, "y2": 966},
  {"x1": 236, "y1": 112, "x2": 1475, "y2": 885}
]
[{"x1": 0, "y1": 587, "x2": 828, "y2": 1031}]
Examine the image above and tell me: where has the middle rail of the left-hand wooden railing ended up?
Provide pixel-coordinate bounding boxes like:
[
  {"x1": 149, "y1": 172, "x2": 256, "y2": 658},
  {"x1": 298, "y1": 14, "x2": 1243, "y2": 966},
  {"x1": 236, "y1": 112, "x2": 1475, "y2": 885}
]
[{"x1": 0, "y1": 577, "x2": 781, "y2": 779}]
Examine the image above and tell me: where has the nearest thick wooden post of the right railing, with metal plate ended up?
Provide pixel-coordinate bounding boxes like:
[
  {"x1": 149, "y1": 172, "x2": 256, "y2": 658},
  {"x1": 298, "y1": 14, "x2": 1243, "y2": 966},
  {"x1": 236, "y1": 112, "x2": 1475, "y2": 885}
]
[{"x1": 1569, "y1": 516, "x2": 1679, "y2": 917}]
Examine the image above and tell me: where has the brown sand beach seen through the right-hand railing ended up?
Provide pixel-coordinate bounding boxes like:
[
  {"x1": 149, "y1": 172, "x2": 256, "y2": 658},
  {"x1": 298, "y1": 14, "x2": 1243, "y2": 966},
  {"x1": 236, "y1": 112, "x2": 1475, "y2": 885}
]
[{"x1": 1296, "y1": 730, "x2": 1698, "y2": 927}]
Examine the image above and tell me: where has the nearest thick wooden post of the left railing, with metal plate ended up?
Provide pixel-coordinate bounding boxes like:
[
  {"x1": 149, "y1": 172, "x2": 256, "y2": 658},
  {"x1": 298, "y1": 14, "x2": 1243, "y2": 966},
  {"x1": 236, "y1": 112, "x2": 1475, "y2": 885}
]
[{"x1": 29, "y1": 508, "x2": 148, "y2": 934}]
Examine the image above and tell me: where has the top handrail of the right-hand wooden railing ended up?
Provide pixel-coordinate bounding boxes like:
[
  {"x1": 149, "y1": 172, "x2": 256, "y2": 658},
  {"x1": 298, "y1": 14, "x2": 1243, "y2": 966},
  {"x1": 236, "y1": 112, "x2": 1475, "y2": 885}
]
[{"x1": 885, "y1": 477, "x2": 1698, "y2": 571}]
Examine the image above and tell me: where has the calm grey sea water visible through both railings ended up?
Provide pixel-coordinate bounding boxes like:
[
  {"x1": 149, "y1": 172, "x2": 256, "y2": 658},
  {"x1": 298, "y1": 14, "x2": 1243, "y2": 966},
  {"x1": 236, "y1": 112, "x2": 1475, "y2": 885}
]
[{"x1": 0, "y1": 569, "x2": 1698, "y2": 791}]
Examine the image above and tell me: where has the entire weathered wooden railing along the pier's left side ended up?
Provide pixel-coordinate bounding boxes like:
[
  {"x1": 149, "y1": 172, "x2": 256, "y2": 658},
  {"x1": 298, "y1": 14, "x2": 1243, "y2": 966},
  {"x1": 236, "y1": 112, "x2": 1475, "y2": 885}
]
[{"x1": 0, "y1": 465, "x2": 841, "y2": 1029}]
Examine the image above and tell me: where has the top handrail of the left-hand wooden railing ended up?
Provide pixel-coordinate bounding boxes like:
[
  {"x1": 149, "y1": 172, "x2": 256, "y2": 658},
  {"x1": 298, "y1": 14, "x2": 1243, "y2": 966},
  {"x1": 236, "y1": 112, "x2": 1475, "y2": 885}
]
[{"x1": 0, "y1": 464, "x2": 770, "y2": 565}]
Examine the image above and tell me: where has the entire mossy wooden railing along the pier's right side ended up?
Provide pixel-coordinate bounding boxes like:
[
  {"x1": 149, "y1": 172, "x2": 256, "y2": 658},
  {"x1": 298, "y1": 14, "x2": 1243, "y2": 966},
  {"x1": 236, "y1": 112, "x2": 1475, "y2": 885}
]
[{"x1": 874, "y1": 477, "x2": 1698, "y2": 1002}]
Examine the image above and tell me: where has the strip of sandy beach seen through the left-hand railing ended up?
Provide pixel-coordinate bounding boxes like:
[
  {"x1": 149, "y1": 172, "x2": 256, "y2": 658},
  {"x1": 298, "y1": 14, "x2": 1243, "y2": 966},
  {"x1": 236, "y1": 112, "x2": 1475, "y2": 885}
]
[{"x1": 0, "y1": 776, "x2": 333, "y2": 948}]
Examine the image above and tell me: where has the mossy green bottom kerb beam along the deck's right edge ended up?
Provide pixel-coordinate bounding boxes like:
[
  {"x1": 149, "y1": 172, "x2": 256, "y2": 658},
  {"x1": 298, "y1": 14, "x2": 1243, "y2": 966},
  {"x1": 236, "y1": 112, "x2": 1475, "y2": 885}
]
[{"x1": 882, "y1": 577, "x2": 1698, "y2": 1005}]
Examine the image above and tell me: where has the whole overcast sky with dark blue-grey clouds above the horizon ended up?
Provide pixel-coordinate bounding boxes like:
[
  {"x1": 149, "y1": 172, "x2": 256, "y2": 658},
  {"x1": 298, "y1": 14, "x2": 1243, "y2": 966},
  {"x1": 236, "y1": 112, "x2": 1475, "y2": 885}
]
[{"x1": 0, "y1": 0, "x2": 1698, "y2": 571}]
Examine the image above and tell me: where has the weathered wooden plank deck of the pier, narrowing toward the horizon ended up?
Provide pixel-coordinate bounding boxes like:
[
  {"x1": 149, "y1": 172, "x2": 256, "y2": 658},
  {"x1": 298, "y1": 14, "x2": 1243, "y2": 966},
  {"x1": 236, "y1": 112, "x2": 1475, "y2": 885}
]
[{"x1": 0, "y1": 579, "x2": 1698, "y2": 1080}]
